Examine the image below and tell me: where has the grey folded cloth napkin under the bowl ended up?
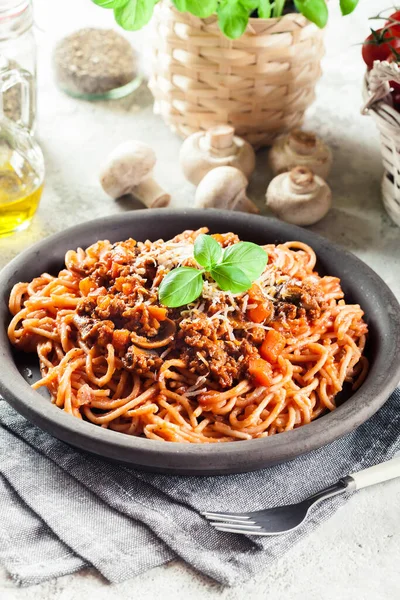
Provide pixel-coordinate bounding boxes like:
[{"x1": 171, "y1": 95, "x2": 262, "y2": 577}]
[{"x1": 0, "y1": 390, "x2": 400, "y2": 585}]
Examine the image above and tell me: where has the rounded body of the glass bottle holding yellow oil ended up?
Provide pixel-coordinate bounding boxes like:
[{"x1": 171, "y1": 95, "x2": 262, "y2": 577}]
[{"x1": 0, "y1": 146, "x2": 43, "y2": 237}]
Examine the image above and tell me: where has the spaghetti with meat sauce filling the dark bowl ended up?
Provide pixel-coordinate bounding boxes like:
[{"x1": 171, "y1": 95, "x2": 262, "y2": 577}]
[{"x1": 8, "y1": 228, "x2": 368, "y2": 443}]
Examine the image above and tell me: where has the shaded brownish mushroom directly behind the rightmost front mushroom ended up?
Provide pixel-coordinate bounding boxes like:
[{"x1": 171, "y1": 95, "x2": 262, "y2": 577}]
[{"x1": 268, "y1": 129, "x2": 332, "y2": 179}]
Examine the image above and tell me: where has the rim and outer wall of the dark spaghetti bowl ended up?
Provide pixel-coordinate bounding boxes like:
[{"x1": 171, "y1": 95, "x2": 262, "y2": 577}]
[{"x1": 0, "y1": 208, "x2": 400, "y2": 475}]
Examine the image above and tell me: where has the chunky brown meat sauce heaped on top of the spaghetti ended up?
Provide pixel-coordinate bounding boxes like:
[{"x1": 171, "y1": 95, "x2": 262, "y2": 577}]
[{"x1": 72, "y1": 230, "x2": 323, "y2": 389}]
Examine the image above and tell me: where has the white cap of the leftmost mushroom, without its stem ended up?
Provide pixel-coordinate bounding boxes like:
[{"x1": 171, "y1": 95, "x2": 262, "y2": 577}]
[{"x1": 100, "y1": 140, "x2": 156, "y2": 198}]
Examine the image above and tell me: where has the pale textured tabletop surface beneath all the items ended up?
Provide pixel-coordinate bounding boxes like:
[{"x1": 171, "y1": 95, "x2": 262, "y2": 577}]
[{"x1": 0, "y1": 0, "x2": 400, "y2": 600}]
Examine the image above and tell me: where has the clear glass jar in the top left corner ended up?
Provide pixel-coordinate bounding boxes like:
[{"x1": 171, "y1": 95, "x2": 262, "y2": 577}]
[{"x1": 0, "y1": 0, "x2": 36, "y2": 131}]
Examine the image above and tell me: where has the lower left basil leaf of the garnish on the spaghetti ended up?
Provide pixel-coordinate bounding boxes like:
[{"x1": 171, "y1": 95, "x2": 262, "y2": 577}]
[{"x1": 158, "y1": 267, "x2": 203, "y2": 308}]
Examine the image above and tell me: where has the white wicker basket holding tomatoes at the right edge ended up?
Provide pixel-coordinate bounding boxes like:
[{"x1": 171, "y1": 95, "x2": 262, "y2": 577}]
[{"x1": 363, "y1": 61, "x2": 400, "y2": 227}]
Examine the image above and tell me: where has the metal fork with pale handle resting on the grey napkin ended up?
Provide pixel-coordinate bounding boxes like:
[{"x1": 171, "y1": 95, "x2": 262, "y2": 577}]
[{"x1": 201, "y1": 457, "x2": 400, "y2": 535}]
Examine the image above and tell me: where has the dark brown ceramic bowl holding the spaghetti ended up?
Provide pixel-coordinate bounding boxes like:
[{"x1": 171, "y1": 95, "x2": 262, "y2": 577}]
[{"x1": 0, "y1": 209, "x2": 400, "y2": 475}]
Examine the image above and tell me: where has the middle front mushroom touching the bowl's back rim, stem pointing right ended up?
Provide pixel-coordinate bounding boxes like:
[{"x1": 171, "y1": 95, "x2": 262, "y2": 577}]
[{"x1": 195, "y1": 167, "x2": 259, "y2": 213}]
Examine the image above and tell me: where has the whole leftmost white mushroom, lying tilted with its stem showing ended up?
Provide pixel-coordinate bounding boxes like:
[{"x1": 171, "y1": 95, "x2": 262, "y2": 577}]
[{"x1": 100, "y1": 140, "x2": 171, "y2": 208}]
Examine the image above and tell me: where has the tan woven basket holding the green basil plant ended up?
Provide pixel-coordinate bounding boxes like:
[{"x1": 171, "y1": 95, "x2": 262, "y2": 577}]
[{"x1": 150, "y1": 0, "x2": 324, "y2": 147}]
